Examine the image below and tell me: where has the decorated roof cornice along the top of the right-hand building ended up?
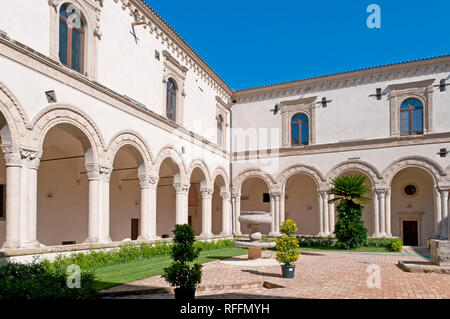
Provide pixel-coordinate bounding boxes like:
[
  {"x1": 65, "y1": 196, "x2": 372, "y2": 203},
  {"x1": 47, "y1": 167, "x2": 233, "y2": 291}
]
[{"x1": 232, "y1": 55, "x2": 450, "y2": 104}]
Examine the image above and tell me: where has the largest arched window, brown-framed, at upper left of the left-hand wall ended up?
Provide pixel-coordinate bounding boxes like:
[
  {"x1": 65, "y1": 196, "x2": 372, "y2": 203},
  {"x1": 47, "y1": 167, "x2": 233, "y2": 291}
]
[{"x1": 59, "y1": 3, "x2": 85, "y2": 73}]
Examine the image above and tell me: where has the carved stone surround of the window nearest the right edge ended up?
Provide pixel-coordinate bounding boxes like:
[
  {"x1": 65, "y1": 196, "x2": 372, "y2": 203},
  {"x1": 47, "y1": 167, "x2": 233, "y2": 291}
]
[{"x1": 387, "y1": 79, "x2": 434, "y2": 136}]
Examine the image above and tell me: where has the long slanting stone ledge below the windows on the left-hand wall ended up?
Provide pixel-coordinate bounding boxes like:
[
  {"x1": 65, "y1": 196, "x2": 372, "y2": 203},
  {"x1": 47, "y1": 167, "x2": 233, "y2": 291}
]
[{"x1": 0, "y1": 34, "x2": 229, "y2": 159}]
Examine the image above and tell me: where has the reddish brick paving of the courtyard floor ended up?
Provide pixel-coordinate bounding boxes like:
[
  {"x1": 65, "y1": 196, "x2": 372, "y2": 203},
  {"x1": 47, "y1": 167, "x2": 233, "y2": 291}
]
[{"x1": 105, "y1": 251, "x2": 450, "y2": 299}]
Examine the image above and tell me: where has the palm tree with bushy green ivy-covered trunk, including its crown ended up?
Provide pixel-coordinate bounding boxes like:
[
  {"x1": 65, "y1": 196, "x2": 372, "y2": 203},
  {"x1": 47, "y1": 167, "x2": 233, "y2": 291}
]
[{"x1": 329, "y1": 175, "x2": 371, "y2": 249}]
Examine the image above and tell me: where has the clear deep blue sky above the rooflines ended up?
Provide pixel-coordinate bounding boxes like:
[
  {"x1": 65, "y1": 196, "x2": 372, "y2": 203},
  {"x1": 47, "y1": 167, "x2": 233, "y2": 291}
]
[{"x1": 146, "y1": 0, "x2": 450, "y2": 89}]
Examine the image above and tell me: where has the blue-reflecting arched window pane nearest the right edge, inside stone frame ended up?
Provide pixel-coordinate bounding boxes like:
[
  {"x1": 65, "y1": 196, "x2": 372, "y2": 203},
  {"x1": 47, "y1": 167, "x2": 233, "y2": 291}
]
[{"x1": 400, "y1": 99, "x2": 423, "y2": 135}]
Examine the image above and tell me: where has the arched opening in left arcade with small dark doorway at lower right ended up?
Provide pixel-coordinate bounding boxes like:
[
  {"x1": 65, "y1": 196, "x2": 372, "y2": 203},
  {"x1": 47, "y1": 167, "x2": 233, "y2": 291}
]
[{"x1": 110, "y1": 145, "x2": 144, "y2": 241}]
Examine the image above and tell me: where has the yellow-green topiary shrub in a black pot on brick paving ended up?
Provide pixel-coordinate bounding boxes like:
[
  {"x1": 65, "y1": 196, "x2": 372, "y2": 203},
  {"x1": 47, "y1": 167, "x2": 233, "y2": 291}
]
[{"x1": 276, "y1": 219, "x2": 299, "y2": 278}]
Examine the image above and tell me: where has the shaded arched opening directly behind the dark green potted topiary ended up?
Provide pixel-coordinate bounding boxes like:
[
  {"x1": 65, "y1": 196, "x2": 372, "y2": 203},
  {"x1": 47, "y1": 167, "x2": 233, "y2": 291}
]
[{"x1": 156, "y1": 158, "x2": 180, "y2": 238}]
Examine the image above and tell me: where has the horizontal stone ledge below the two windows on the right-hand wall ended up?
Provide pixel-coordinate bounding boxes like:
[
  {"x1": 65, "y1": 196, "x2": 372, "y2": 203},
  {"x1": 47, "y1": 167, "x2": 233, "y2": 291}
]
[{"x1": 233, "y1": 132, "x2": 450, "y2": 161}]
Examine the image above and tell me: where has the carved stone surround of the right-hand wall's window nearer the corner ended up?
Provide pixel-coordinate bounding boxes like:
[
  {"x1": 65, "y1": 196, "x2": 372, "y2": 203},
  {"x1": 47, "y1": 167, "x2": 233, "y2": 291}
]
[{"x1": 280, "y1": 96, "x2": 317, "y2": 147}]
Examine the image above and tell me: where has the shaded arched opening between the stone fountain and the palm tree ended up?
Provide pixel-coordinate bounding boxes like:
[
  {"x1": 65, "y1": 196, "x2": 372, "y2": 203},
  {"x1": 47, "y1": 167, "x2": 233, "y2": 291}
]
[{"x1": 284, "y1": 174, "x2": 320, "y2": 235}]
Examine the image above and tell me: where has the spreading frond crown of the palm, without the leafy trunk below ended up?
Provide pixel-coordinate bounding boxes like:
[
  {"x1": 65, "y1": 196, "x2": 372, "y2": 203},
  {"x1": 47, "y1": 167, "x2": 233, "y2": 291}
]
[{"x1": 328, "y1": 175, "x2": 371, "y2": 205}]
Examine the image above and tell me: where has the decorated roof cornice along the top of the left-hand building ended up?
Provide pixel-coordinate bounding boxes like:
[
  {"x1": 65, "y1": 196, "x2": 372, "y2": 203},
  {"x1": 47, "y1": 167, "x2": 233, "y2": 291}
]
[{"x1": 122, "y1": 0, "x2": 233, "y2": 99}]
